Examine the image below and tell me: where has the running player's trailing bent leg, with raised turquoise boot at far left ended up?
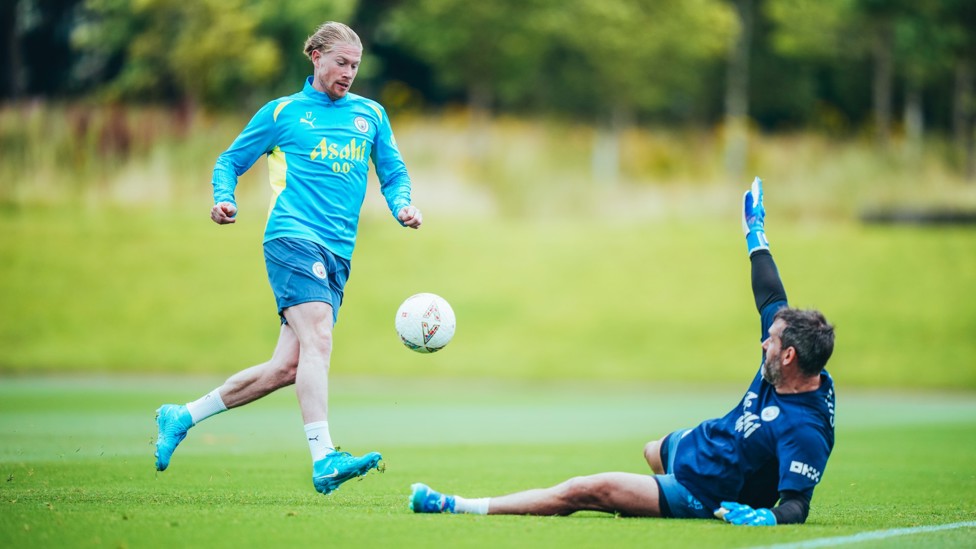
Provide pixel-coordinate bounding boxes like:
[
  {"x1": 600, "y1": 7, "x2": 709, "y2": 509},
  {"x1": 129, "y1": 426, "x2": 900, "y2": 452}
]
[{"x1": 154, "y1": 324, "x2": 299, "y2": 471}]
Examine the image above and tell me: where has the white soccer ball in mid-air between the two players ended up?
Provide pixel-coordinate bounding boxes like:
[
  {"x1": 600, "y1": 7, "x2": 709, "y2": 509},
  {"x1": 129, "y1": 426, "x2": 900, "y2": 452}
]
[{"x1": 396, "y1": 294, "x2": 455, "y2": 353}]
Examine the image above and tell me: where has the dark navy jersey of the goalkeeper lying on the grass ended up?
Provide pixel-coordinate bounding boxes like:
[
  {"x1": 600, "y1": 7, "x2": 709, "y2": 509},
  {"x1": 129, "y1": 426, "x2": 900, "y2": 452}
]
[{"x1": 673, "y1": 301, "x2": 834, "y2": 510}]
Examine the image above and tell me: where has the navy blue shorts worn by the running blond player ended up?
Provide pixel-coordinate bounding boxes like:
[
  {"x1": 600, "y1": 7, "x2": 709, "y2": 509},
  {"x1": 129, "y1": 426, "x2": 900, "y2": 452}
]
[{"x1": 264, "y1": 238, "x2": 350, "y2": 324}]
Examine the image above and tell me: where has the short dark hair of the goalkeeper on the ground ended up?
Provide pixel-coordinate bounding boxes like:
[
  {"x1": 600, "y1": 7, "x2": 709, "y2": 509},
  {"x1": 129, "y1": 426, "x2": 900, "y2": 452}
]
[{"x1": 773, "y1": 307, "x2": 834, "y2": 376}]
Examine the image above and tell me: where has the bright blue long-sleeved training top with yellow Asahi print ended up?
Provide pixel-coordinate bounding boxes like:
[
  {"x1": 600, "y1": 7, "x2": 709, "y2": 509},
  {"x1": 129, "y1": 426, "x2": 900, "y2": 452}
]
[{"x1": 213, "y1": 77, "x2": 410, "y2": 259}]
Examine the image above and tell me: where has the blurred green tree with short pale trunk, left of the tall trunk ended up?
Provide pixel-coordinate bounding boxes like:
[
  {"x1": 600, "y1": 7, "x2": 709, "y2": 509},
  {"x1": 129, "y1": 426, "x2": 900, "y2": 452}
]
[{"x1": 540, "y1": 0, "x2": 739, "y2": 184}]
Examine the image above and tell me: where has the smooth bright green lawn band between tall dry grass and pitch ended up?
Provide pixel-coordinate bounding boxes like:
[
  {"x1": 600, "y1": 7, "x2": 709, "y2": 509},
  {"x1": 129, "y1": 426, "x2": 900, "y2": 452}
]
[{"x1": 0, "y1": 206, "x2": 976, "y2": 389}]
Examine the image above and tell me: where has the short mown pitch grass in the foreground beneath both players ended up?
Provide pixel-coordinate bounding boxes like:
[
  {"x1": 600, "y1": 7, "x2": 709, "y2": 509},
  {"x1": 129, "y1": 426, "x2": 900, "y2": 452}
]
[{"x1": 0, "y1": 377, "x2": 976, "y2": 547}]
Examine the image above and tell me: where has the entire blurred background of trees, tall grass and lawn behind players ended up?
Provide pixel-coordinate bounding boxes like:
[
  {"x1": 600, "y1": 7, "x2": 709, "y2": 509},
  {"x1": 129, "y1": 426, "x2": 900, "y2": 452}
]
[{"x1": 0, "y1": 0, "x2": 976, "y2": 389}]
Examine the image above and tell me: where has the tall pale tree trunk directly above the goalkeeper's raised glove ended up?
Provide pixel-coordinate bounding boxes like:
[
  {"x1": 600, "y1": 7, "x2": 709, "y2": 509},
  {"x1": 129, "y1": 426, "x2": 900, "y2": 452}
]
[{"x1": 725, "y1": 0, "x2": 753, "y2": 181}]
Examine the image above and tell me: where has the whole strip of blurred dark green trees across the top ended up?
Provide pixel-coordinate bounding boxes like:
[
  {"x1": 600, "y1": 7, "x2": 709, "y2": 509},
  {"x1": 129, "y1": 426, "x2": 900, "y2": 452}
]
[{"x1": 7, "y1": 0, "x2": 976, "y2": 135}]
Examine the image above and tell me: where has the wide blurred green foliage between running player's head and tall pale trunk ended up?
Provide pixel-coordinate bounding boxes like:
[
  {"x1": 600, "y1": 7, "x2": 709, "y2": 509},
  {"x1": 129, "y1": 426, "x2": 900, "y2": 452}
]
[{"x1": 387, "y1": 0, "x2": 736, "y2": 112}]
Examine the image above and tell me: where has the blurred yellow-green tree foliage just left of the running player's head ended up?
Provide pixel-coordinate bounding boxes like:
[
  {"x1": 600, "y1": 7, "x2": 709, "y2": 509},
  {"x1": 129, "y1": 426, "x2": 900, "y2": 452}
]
[{"x1": 73, "y1": 0, "x2": 355, "y2": 107}]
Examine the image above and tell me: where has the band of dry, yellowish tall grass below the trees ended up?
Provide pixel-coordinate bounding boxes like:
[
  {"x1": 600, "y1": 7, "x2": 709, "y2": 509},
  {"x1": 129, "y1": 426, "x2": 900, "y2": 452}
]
[{"x1": 0, "y1": 102, "x2": 976, "y2": 220}]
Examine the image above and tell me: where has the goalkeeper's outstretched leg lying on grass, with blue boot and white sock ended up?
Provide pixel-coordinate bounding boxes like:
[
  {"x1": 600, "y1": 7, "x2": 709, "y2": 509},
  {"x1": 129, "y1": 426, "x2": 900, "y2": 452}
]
[{"x1": 410, "y1": 473, "x2": 661, "y2": 517}]
